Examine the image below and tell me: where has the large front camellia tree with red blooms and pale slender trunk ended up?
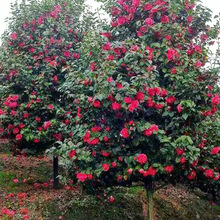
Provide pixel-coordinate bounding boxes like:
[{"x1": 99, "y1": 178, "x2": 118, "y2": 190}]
[{"x1": 55, "y1": 0, "x2": 220, "y2": 220}]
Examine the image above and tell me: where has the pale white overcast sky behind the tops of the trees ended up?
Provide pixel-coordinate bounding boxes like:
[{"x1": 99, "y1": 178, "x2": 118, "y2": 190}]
[{"x1": 0, "y1": 0, "x2": 220, "y2": 35}]
